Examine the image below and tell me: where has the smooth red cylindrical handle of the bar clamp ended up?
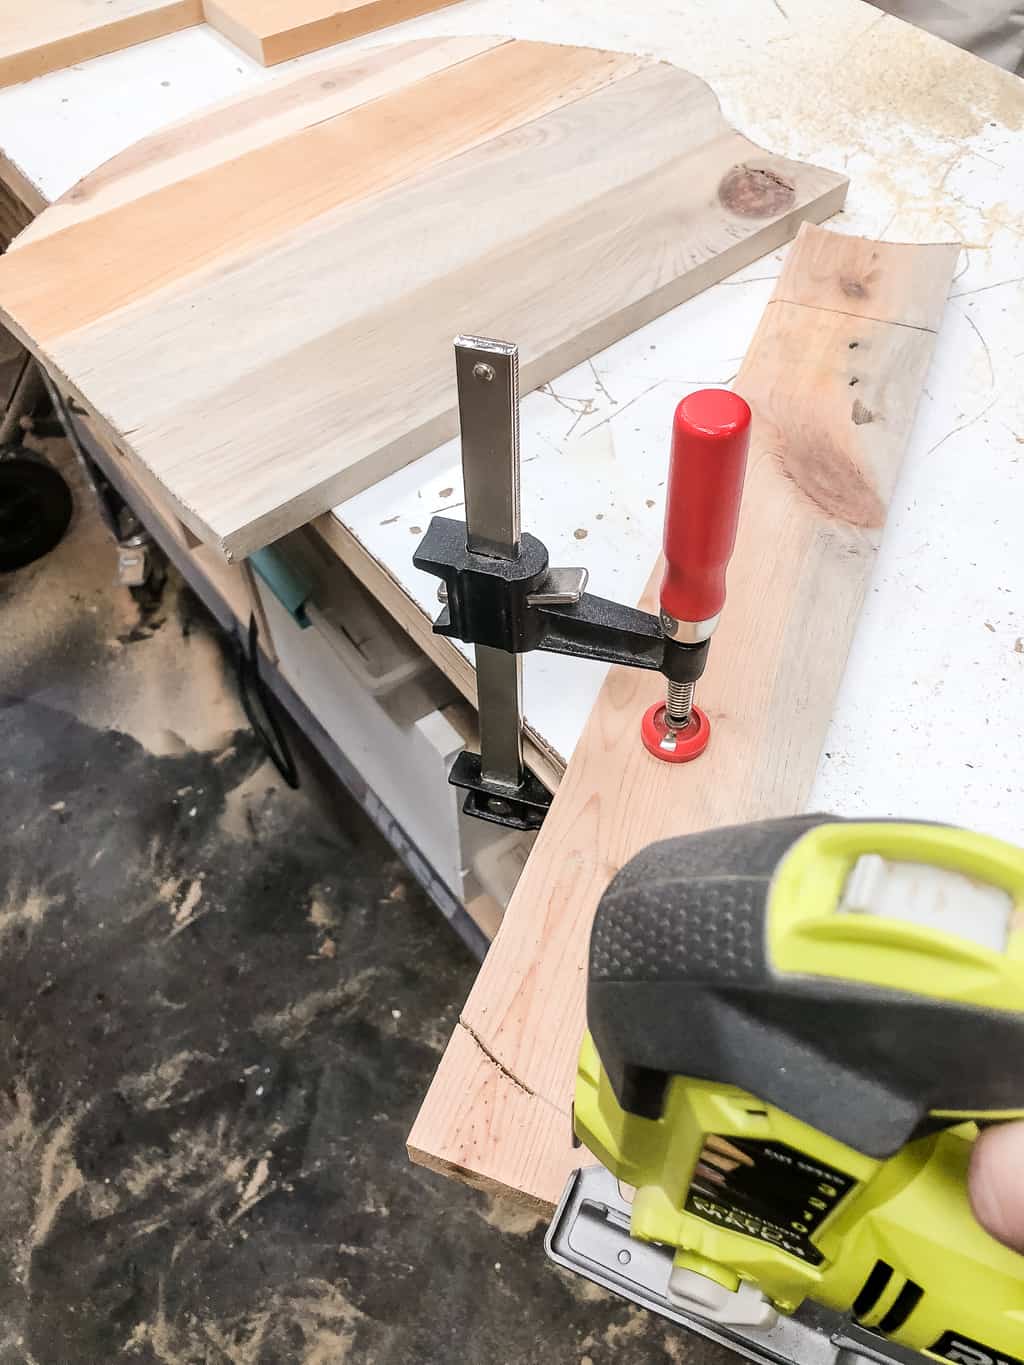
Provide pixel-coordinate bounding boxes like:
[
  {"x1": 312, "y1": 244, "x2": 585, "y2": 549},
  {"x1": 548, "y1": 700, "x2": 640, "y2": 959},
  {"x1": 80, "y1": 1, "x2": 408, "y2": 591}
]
[{"x1": 661, "y1": 389, "x2": 751, "y2": 622}]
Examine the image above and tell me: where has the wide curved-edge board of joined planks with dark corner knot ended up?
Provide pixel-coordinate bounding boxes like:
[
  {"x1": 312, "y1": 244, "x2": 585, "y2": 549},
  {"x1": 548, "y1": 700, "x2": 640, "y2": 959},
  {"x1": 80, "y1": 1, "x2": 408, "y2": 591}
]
[{"x1": 0, "y1": 38, "x2": 847, "y2": 557}]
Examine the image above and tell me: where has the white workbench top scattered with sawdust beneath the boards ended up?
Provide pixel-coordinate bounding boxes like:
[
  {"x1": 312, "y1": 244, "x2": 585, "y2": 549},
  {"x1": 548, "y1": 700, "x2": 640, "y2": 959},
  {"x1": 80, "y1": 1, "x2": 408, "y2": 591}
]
[{"x1": 0, "y1": 0, "x2": 1024, "y2": 839}]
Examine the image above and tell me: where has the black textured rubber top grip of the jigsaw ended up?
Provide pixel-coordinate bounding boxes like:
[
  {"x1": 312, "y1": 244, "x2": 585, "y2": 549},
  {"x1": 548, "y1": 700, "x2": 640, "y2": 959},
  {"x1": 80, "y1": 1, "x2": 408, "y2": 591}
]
[{"x1": 587, "y1": 815, "x2": 1024, "y2": 1158}]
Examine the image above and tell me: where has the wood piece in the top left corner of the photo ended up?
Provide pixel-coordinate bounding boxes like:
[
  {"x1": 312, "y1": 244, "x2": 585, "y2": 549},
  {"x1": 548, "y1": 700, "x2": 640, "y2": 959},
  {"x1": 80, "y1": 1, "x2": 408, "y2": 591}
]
[{"x1": 0, "y1": 0, "x2": 202, "y2": 86}]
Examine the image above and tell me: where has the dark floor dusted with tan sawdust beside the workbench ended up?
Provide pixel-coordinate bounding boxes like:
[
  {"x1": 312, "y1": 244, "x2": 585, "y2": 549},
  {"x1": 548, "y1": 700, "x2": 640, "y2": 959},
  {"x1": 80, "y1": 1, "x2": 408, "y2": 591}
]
[{"x1": 0, "y1": 442, "x2": 730, "y2": 1365}]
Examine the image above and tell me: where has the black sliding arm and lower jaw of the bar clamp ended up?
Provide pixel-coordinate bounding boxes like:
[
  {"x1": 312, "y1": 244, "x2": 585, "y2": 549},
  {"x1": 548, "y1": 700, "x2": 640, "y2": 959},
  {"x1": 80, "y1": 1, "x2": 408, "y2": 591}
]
[{"x1": 412, "y1": 516, "x2": 707, "y2": 830}]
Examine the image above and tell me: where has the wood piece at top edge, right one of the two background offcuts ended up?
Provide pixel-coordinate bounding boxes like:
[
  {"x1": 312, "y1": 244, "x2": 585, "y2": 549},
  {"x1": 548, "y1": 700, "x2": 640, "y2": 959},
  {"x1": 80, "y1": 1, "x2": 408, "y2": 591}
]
[{"x1": 203, "y1": 0, "x2": 453, "y2": 67}]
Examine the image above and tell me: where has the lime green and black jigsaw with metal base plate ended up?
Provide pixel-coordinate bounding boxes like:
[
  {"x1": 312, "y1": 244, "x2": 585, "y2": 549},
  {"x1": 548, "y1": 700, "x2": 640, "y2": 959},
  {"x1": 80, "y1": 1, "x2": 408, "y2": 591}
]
[{"x1": 547, "y1": 816, "x2": 1024, "y2": 1365}]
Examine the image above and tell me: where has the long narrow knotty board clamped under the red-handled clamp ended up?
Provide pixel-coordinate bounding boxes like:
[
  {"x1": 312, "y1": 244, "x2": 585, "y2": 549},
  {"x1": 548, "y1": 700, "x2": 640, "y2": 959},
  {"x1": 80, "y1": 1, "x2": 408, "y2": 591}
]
[{"x1": 408, "y1": 225, "x2": 958, "y2": 1205}]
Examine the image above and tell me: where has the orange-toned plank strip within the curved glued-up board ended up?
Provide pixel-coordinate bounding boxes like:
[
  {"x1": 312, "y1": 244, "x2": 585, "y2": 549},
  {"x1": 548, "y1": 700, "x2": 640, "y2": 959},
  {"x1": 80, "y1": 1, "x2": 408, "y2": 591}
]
[{"x1": 3, "y1": 42, "x2": 636, "y2": 345}]
